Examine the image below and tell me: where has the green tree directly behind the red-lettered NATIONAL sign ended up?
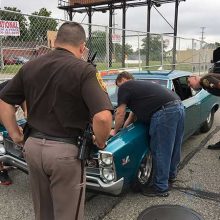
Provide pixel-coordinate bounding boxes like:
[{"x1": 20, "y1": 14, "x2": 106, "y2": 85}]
[{"x1": 0, "y1": 7, "x2": 28, "y2": 41}]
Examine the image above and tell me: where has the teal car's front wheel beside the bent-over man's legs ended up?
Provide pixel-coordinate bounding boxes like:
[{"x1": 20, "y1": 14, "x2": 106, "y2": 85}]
[{"x1": 131, "y1": 152, "x2": 153, "y2": 192}]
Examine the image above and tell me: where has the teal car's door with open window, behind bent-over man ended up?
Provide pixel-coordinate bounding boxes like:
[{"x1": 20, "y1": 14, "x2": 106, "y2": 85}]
[{"x1": 173, "y1": 76, "x2": 201, "y2": 139}]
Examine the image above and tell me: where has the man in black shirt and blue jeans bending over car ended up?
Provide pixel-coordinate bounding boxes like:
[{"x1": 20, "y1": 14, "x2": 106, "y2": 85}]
[{"x1": 111, "y1": 72, "x2": 184, "y2": 197}]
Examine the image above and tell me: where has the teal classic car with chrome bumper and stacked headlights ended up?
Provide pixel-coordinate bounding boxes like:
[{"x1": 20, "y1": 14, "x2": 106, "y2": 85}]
[{"x1": 0, "y1": 71, "x2": 220, "y2": 195}]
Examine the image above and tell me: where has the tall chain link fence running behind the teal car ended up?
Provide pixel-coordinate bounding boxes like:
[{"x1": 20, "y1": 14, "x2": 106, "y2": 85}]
[{"x1": 0, "y1": 10, "x2": 215, "y2": 78}]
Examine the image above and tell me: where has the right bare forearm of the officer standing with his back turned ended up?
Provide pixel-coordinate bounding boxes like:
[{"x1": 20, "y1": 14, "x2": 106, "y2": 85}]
[{"x1": 92, "y1": 110, "x2": 112, "y2": 149}]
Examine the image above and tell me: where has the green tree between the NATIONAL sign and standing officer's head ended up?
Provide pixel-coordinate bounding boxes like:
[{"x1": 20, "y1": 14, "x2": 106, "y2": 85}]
[{"x1": 29, "y1": 8, "x2": 58, "y2": 41}]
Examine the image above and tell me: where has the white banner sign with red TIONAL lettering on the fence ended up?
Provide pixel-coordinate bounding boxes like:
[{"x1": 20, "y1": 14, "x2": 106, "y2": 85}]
[{"x1": 0, "y1": 20, "x2": 20, "y2": 36}]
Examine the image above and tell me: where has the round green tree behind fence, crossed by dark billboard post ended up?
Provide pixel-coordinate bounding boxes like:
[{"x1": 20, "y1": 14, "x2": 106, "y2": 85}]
[{"x1": 141, "y1": 35, "x2": 167, "y2": 61}]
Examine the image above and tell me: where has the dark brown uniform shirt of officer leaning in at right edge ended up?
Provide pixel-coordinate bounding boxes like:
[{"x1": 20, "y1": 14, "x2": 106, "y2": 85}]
[{"x1": 200, "y1": 73, "x2": 220, "y2": 96}]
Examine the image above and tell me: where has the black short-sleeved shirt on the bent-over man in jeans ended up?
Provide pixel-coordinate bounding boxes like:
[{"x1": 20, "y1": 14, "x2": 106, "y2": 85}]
[{"x1": 118, "y1": 80, "x2": 180, "y2": 122}]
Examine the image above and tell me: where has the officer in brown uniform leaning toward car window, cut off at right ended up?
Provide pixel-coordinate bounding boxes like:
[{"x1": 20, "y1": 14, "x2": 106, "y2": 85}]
[{"x1": 188, "y1": 73, "x2": 220, "y2": 153}]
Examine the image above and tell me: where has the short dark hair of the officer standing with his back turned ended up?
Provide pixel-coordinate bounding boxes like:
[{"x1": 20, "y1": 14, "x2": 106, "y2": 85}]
[{"x1": 55, "y1": 22, "x2": 86, "y2": 46}]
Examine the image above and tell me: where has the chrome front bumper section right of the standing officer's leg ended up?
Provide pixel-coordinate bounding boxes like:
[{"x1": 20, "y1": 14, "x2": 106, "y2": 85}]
[{"x1": 86, "y1": 175, "x2": 124, "y2": 195}]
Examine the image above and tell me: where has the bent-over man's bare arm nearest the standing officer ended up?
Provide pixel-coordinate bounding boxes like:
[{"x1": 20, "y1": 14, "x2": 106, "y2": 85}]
[{"x1": 110, "y1": 104, "x2": 126, "y2": 136}]
